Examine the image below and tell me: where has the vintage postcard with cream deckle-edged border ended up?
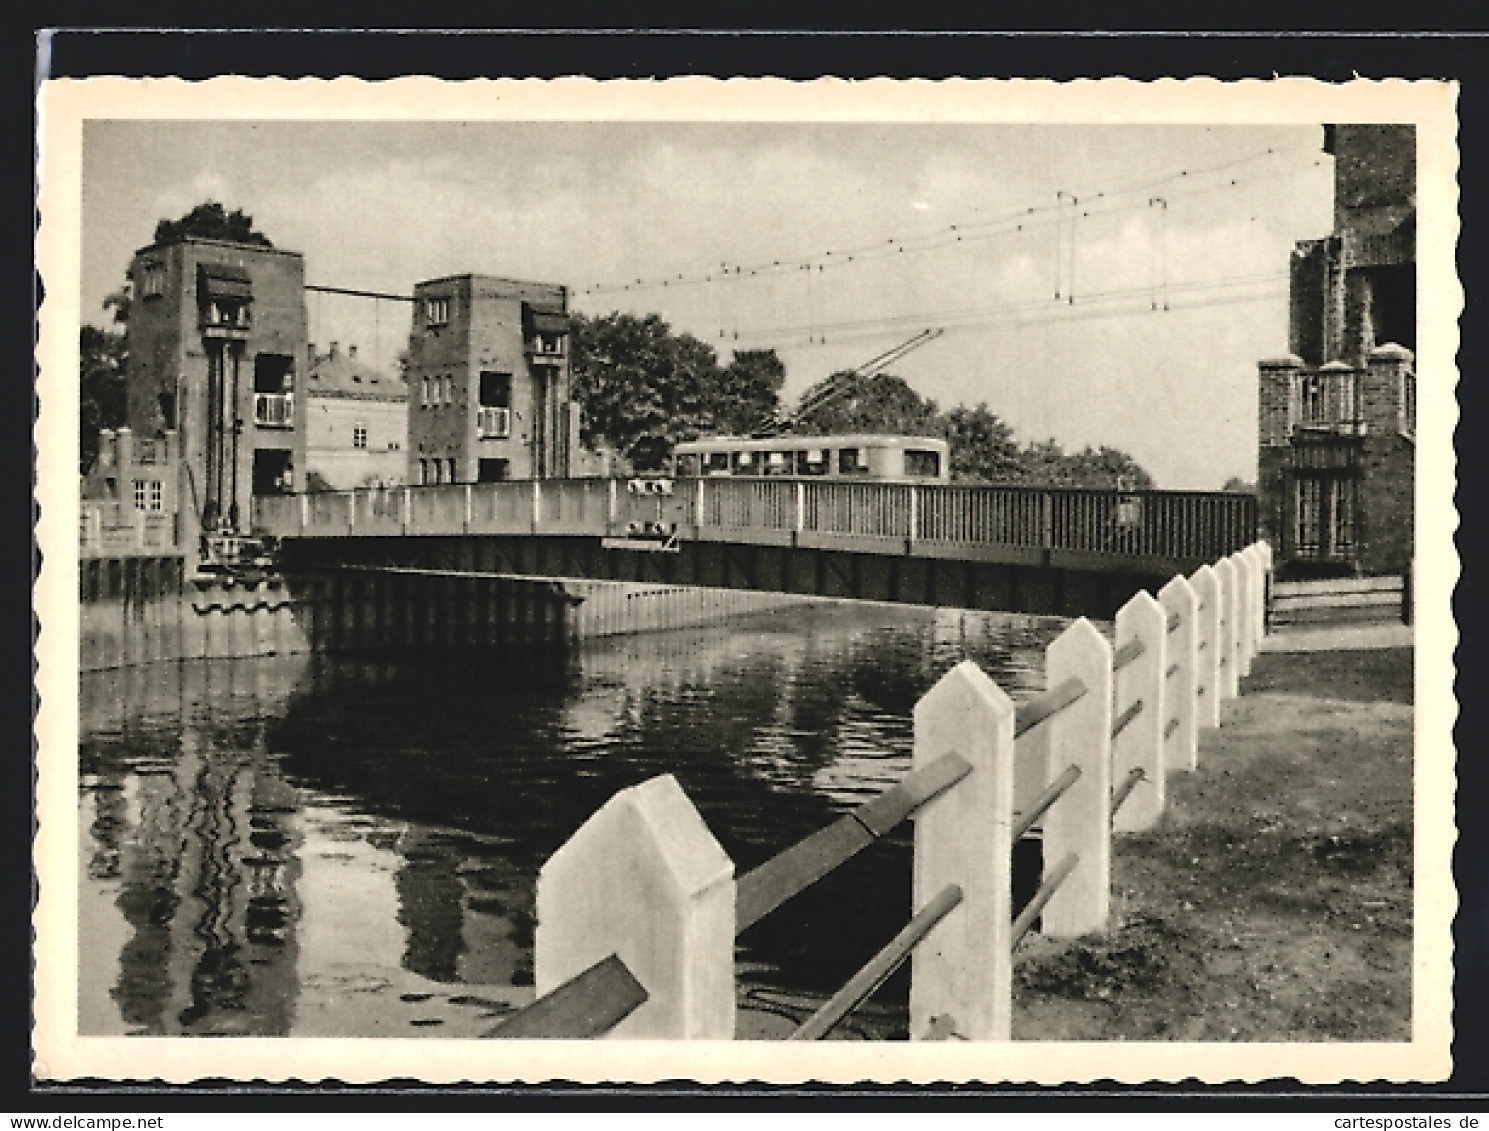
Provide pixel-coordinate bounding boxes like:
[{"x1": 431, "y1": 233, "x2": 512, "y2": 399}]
[{"x1": 34, "y1": 77, "x2": 1462, "y2": 1083}]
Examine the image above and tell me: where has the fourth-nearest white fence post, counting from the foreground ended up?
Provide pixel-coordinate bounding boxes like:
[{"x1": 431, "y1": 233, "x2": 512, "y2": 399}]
[{"x1": 1112, "y1": 589, "x2": 1167, "y2": 832}]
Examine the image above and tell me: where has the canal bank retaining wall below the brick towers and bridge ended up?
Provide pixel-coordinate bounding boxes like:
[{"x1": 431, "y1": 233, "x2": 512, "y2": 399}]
[{"x1": 79, "y1": 555, "x2": 810, "y2": 671}]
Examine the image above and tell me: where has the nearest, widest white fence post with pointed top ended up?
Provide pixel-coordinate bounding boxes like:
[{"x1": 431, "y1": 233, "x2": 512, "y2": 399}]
[{"x1": 533, "y1": 774, "x2": 736, "y2": 1040}]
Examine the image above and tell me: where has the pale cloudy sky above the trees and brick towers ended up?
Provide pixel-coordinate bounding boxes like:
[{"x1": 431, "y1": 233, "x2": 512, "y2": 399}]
[{"x1": 80, "y1": 121, "x2": 1333, "y2": 490}]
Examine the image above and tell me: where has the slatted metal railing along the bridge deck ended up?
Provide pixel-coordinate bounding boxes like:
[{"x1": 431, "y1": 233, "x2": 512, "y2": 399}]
[{"x1": 255, "y1": 478, "x2": 1257, "y2": 561}]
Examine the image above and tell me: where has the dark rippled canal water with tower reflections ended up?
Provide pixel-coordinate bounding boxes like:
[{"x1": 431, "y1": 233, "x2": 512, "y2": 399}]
[{"x1": 79, "y1": 603, "x2": 1063, "y2": 1037}]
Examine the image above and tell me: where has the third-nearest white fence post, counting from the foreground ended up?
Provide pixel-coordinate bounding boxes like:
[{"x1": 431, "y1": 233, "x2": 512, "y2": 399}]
[{"x1": 1041, "y1": 616, "x2": 1112, "y2": 938}]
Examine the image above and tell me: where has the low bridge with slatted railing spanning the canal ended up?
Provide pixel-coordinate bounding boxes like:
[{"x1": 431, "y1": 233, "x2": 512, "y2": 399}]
[{"x1": 253, "y1": 478, "x2": 1257, "y2": 618}]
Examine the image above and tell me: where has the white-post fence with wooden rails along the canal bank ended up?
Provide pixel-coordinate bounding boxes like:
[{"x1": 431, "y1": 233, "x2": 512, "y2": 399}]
[{"x1": 491, "y1": 543, "x2": 1272, "y2": 1040}]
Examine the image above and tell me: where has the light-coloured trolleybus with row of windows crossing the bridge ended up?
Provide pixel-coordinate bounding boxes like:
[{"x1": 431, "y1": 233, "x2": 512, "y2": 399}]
[{"x1": 673, "y1": 435, "x2": 951, "y2": 484}]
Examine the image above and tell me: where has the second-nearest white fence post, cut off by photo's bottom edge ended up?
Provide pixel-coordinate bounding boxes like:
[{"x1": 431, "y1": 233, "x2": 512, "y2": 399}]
[{"x1": 910, "y1": 661, "x2": 1014, "y2": 1040}]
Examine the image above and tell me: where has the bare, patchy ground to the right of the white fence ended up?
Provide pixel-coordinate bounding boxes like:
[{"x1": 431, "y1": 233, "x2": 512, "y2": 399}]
[{"x1": 1014, "y1": 647, "x2": 1412, "y2": 1042}]
